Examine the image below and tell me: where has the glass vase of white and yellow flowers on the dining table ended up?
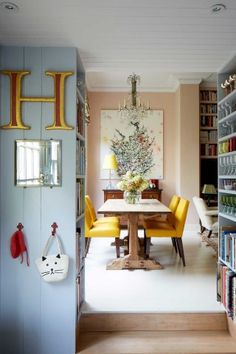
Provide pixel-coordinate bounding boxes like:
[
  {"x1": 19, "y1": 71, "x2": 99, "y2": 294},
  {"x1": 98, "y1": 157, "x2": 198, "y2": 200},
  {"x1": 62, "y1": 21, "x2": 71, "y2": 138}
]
[{"x1": 117, "y1": 171, "x2": 149, "y2": 204}]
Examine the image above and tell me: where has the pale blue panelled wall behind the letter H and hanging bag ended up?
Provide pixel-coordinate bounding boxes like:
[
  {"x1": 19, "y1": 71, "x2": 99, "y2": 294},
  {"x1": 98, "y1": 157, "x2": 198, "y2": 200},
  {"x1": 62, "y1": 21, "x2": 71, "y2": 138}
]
[{"x1": 0, "y1": 47, "x2": 77, "y2": 354}]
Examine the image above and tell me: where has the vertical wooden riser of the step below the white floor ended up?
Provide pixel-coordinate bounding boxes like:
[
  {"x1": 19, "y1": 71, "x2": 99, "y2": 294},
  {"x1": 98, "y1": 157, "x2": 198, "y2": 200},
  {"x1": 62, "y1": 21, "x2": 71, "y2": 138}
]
[{"x1": 80, "y1": 312, "x2": 228, "y2": 332}]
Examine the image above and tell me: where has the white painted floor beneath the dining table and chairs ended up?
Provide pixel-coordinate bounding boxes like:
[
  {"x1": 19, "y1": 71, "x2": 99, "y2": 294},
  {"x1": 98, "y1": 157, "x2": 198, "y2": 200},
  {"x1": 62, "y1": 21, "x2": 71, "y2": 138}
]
[{"x1": 83, "y1": 232, "x2": 223, "y2": 312}]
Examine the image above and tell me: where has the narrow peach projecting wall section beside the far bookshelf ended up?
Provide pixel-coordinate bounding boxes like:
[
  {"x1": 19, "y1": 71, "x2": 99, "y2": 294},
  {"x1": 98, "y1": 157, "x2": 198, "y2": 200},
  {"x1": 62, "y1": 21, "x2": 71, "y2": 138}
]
[{"x1": 177, "y1": 85, "x2": 200, "y2": 224}]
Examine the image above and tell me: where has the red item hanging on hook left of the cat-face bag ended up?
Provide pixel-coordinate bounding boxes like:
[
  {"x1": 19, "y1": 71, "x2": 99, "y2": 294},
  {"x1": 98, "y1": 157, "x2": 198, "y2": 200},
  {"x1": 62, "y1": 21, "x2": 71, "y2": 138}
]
[{"x1": 10, "y1": 223, "x2": 29, "y2": 266}]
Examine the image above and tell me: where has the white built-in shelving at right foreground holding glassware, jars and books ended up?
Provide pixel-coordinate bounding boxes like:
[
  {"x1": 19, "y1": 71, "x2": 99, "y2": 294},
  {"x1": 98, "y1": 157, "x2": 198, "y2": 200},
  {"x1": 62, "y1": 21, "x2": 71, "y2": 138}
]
[{"x1": 217, "y1": 54, "x2": 236, "y2": 321}]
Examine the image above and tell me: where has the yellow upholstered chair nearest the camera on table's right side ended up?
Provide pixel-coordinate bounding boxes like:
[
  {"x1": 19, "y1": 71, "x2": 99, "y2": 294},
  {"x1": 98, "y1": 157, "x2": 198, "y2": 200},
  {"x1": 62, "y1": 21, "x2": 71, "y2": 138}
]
[{"x1": 144, "y1": 198, "x2": 189, "y2": 266}]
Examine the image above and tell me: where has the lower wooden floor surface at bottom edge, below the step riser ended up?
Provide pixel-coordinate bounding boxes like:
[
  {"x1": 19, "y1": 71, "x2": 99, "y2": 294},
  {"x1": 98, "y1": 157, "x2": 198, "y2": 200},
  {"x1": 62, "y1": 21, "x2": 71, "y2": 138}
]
[{"x1": 78, "y1": 331, "x2": 236, "y2": 354}]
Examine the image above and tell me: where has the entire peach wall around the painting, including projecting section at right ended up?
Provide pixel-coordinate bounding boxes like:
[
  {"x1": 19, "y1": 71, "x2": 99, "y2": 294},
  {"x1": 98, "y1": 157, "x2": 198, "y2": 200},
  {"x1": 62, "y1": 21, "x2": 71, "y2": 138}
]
[{"x1": 87, "y1": 85, "x2": 199, "y2": 228}]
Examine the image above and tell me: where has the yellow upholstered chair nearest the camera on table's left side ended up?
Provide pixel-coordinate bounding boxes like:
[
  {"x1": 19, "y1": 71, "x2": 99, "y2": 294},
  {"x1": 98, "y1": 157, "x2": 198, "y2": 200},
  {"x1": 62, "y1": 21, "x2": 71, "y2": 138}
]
[{"x1": 85, "y1": 202, "x2": 120, "y2": 258}]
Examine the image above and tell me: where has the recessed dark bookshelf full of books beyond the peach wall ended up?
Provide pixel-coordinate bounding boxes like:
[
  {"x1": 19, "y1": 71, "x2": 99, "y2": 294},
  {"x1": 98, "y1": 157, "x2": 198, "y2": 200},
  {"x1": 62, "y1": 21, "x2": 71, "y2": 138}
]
[{"x1": 199, "y1": 86, "x2": 218, "y2": 203}]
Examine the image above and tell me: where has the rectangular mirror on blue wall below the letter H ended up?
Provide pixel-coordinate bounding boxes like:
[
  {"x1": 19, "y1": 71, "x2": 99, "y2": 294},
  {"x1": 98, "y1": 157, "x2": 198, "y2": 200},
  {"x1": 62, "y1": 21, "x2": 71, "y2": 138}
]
[{"x1": 15, "y1": 140, "x2": 61, "y2": 187}]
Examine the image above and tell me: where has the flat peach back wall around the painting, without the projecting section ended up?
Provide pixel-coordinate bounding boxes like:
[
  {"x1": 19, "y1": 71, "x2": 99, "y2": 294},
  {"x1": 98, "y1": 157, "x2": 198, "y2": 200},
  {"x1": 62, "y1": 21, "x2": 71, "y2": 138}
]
[{"x1": 87, "y1": 92, "x2": 176, "y2": 213}]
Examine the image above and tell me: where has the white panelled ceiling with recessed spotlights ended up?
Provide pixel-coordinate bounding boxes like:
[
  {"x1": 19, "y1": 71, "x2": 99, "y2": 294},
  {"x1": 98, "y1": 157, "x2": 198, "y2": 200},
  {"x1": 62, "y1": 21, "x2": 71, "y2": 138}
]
[{"x1": 0, "y1": 0, "x2": 236, "y2": 91}]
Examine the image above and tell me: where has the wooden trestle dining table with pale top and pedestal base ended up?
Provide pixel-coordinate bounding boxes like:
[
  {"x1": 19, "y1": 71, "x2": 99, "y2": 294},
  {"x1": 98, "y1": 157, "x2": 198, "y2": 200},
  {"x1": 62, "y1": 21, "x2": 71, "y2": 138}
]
[{"x1": 98, "y1": 199, "x2": 171, "y2": 270}]
